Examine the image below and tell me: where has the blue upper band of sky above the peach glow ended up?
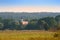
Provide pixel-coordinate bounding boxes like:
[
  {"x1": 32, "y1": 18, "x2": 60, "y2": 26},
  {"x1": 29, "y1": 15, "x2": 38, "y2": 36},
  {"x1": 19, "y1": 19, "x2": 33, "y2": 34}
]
[{"x1": 0, "y1": 0, "x2": 60, "y2": 7}]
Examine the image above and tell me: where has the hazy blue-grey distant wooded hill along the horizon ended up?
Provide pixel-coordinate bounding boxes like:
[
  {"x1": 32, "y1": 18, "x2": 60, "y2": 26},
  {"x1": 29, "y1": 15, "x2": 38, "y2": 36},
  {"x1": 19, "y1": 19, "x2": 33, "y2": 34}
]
[{"x1": 0, "y1": 12, "x2": 60, "y2": 19}]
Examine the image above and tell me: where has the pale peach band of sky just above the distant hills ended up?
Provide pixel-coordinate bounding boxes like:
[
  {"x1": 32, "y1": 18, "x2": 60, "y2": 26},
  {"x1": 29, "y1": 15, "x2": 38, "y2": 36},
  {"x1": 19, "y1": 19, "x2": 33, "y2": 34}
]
[{"x1": 0, "y1": 6, "x2": 60, "y2": 12}]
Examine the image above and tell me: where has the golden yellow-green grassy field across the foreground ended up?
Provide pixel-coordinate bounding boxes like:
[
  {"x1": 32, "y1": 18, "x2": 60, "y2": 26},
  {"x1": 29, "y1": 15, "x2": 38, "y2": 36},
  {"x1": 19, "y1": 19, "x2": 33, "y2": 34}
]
[{"x1": 0, "y1": 30, "x2": 60, "y2": 40}]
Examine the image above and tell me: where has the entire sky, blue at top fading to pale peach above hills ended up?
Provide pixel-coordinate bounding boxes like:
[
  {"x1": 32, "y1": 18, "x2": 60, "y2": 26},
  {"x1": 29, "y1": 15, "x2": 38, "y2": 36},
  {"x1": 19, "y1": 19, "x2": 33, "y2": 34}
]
[{"x1": 0, "y1": 0, "x2": 60, "y2": 12}]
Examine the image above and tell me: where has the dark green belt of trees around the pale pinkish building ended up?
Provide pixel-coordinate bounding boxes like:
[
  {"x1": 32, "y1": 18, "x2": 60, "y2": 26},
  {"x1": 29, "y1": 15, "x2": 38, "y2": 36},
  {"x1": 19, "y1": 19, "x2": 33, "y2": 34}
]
[{"x1": 0, "y1": 15, "x2": 60, "y2": 30}]
